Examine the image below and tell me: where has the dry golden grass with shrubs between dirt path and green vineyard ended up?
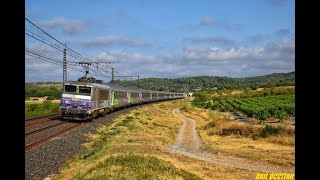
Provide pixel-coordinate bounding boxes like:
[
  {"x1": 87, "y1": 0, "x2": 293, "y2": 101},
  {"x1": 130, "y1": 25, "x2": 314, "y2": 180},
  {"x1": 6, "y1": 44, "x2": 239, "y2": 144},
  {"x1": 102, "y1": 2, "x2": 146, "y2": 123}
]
[{"x1": 181, "y1": 105, "x2": 295, "y2": 166}]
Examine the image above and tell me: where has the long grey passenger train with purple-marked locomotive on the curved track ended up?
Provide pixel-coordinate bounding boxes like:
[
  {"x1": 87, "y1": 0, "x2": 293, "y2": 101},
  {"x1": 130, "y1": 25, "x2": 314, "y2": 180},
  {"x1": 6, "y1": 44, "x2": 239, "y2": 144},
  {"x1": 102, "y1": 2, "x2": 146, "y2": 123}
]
[{"x1": 60, "y1": 81, "x2": 186, "y2": 121}]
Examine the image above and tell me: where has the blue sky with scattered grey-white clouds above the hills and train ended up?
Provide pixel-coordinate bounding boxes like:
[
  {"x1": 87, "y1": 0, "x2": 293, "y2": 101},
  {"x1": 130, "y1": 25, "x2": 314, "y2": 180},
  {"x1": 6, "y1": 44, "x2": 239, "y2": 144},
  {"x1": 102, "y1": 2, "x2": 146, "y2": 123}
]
[{"x1": 25, "y1": 0, "x2": 295, "y2": 82}]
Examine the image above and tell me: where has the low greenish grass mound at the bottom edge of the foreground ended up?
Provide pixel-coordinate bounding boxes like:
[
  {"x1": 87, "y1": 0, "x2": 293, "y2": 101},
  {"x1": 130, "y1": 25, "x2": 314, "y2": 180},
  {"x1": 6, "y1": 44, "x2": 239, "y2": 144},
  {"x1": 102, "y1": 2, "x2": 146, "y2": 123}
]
[{"x1": 65, "y1": 154, "x2": 199, "y2": 179}]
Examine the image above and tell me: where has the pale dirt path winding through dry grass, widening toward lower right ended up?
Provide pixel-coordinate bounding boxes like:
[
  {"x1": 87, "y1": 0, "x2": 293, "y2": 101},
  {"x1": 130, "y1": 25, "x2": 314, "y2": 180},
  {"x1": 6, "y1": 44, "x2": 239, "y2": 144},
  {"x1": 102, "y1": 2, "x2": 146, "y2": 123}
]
[{"x1": 168, "y1": 108, "x2": 294, "y2": 173}]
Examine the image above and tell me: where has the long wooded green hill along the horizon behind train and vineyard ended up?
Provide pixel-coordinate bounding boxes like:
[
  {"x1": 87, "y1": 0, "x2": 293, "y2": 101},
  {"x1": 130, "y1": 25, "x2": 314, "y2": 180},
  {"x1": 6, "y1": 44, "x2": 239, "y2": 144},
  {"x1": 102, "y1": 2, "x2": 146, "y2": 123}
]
[{"x1": 115, "y1": 71, "x2": 295, "y2": 91}]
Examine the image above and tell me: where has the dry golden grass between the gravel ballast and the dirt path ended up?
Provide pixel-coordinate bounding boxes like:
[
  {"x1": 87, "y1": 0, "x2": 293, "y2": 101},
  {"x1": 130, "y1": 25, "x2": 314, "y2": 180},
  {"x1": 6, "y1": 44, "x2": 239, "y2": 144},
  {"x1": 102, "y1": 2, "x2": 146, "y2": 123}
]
[{"x1": 53, "y1": 100, "x2": 257, "y2": 180}]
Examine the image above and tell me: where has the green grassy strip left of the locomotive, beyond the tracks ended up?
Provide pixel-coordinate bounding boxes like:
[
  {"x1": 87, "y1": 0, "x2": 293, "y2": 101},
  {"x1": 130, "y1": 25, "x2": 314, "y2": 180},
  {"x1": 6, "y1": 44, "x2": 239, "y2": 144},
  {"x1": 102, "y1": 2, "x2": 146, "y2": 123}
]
[{"x1": 25, "y1": 101, "x2": 60, "y2": 118}]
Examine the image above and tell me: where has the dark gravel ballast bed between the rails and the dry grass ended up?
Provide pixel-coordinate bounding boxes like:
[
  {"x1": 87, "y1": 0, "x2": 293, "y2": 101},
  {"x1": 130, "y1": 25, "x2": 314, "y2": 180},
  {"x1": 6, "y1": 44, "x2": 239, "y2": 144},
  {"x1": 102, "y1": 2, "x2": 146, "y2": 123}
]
[{"x1": 25, "y1": 102, "x2": 152, "y2": 180}]
